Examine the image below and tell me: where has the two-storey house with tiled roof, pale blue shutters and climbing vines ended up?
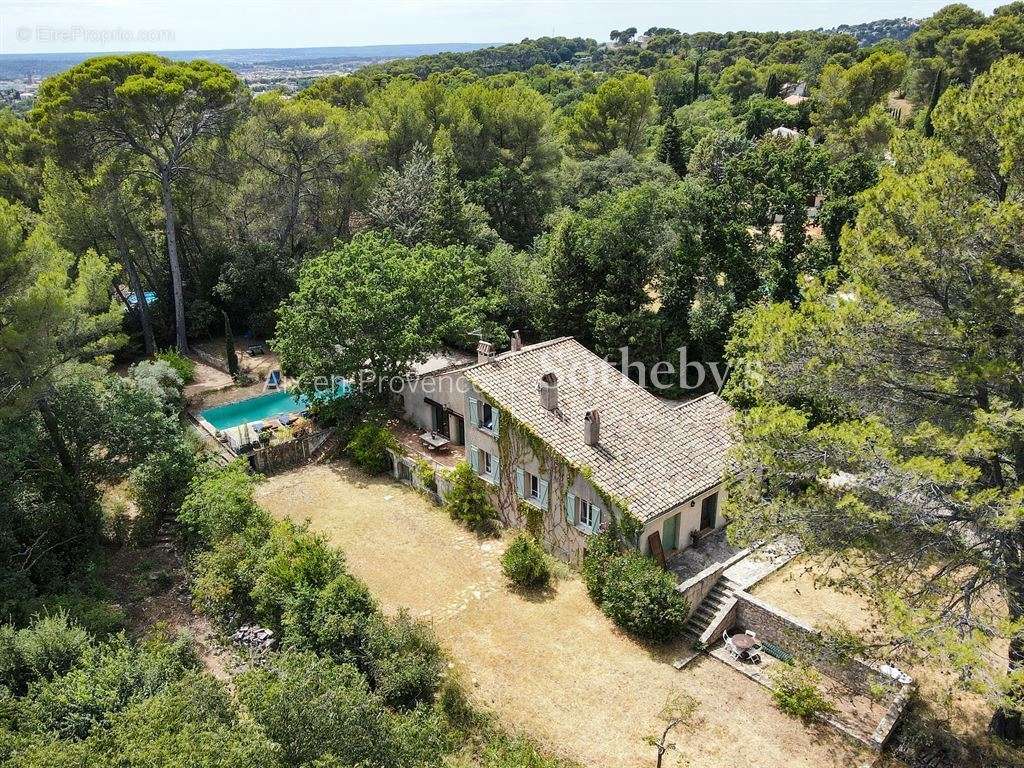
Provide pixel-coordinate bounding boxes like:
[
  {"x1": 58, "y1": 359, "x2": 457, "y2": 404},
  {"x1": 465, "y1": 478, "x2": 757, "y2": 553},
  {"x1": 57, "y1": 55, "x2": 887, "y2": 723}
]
[{"x1": 463, "y1": 338, "x2": 732, "y2": 561}]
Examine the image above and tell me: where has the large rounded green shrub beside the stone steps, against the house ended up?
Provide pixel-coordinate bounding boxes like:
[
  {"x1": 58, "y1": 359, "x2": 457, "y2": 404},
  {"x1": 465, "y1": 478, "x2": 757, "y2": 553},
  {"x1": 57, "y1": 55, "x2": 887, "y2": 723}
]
[{"x1": 601, "y1": 550, "x2": 689, "y2": 641}]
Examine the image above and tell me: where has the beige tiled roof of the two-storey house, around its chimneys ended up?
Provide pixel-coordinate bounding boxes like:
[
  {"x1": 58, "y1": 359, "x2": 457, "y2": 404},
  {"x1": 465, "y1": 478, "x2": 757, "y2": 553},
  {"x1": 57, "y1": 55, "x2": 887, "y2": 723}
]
[{"x1": 466, "y1": 337, "x2": 732, "y2": 521}]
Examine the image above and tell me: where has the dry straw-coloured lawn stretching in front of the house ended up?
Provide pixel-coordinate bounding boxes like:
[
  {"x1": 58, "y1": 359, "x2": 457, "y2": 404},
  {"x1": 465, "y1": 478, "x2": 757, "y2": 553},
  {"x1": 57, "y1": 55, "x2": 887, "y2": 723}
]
[{"x1": 258, "y1": 464, "x2": 870, "y2": 768}]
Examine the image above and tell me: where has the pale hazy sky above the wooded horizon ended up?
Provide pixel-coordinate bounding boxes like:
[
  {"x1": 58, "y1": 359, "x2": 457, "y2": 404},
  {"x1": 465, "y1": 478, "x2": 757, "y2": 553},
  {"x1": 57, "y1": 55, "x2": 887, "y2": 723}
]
[{"x1": 0, "y1": 0, "x2": 1010, "y2": 53}]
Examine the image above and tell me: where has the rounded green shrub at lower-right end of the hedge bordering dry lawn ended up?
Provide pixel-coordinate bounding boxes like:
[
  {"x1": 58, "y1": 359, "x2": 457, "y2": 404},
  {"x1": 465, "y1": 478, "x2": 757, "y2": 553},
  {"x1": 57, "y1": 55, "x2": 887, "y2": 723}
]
[{"x1": 364, "y1": 610, "x2": 445, "y2": 710}]
